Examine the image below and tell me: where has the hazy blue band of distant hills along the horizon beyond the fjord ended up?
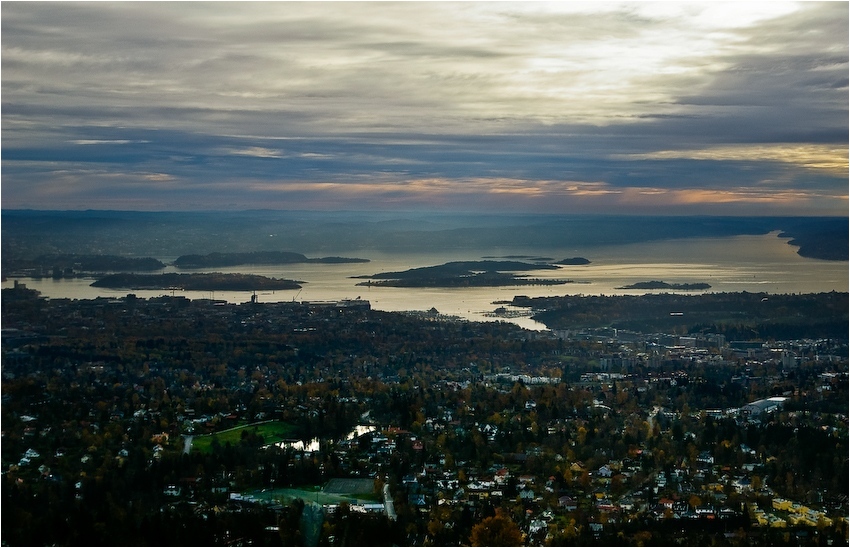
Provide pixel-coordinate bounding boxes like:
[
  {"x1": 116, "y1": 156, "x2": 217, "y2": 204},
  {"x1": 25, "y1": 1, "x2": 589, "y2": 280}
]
[{"x1": 0, "y1": 210, "x2": 850, "y2": 262}]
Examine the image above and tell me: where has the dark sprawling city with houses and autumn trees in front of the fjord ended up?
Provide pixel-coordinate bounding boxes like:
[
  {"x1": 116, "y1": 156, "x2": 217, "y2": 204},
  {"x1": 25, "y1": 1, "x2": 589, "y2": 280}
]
[{"x1": 2, "y1": 284, "x2": 848, "y2": 546}]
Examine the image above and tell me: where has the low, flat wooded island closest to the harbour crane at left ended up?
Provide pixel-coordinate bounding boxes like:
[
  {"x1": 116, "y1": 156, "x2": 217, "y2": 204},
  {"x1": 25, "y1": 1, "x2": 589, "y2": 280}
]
[{"x1": 91, "y1": 272, "x2": 304, "y2": 291}]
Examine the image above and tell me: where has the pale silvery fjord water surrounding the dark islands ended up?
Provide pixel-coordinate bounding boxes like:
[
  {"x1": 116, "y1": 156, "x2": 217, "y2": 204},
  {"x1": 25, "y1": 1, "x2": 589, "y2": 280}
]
[{"x1": 3, "y1": 232, "x2": 848, "y2": 329}]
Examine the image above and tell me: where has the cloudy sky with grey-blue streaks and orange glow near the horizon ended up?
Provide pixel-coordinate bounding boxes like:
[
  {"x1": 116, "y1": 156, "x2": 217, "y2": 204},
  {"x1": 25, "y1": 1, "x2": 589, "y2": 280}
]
[{"x1": 0, "y1": 1, "x2": 849, "y2": 216}]
